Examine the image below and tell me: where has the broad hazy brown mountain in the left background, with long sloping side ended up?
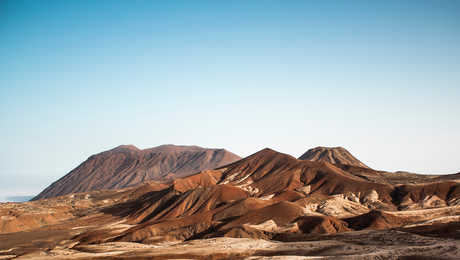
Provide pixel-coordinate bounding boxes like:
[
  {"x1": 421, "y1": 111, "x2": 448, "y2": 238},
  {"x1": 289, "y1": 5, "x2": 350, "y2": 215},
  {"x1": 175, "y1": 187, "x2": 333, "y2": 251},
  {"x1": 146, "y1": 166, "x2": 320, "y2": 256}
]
[{"x1": 33, "y1": 145, "x2": 240, "y2": 200}]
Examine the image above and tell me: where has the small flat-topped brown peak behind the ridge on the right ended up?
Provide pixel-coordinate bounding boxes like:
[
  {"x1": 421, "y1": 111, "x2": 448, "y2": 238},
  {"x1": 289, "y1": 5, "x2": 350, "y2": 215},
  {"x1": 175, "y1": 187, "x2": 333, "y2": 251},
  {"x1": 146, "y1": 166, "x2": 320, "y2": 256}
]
[{"x1": 299, "y1": 146, "x2": 369, "y2": 169}]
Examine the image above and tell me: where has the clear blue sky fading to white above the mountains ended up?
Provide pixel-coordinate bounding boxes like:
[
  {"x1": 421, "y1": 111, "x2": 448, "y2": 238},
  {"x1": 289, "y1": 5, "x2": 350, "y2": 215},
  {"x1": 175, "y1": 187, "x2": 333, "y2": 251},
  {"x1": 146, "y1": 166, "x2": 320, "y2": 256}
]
[{"x1": 0, "y1": 0, "x2": 460, "y2": 200}]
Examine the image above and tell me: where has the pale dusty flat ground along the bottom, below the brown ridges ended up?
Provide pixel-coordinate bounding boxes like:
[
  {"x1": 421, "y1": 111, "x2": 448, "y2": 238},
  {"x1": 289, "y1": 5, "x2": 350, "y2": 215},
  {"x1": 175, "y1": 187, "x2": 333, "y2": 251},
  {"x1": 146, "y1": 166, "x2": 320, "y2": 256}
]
[{"x1": 0, "y1": 227, "x2": 460, "y2": 259}]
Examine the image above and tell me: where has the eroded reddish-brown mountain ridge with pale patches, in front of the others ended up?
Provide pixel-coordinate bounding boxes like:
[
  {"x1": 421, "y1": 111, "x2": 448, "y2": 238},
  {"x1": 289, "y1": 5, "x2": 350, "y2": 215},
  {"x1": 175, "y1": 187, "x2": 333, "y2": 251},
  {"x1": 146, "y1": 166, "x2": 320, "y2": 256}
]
[{"x1": 63, "y1": 148, "x2": 460, "y2": 244}]
